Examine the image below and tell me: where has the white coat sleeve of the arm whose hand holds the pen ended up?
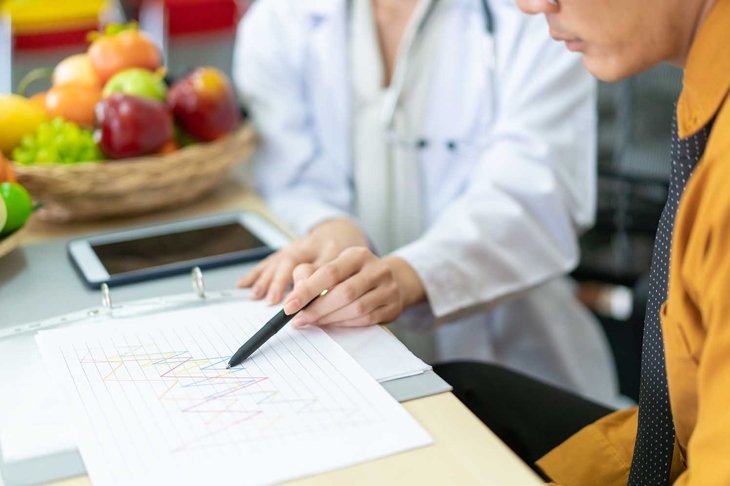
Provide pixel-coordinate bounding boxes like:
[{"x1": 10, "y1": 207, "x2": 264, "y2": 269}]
[{"x1": 395, "y1": 16, "x2": 596, "y2": 320}]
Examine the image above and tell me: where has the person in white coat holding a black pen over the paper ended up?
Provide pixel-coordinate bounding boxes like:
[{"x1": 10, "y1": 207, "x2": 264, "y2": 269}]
[{"x1": 234, "y1": 0, "x2": 617, "y2": 403}]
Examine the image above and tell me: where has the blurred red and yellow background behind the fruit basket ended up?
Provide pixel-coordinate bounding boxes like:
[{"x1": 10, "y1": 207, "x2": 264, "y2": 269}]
[{"x1": 0, "y1": 0, "x2": 249, "y2": 95}]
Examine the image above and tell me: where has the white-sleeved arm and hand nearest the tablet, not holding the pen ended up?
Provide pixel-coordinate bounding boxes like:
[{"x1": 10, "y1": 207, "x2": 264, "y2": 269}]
[{"x1": 234, "y1": 1, "x2": 367, "y2": 303}]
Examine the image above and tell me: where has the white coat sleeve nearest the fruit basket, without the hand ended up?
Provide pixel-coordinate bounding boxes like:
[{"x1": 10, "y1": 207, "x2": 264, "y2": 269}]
[{"x1": 234, "y1": 1, "x2": 351, "y2": 234}]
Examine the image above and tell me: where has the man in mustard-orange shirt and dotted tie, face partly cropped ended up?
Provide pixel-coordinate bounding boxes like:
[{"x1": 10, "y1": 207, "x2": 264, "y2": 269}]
[{"x1": 436, "y1": 0, "x2": 730, "y2": 486}]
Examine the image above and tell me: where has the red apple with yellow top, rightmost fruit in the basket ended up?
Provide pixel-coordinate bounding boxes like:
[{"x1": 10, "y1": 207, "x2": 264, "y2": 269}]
[{"x1": 167, "y1": 67, "x2": 240, "y2": 142}]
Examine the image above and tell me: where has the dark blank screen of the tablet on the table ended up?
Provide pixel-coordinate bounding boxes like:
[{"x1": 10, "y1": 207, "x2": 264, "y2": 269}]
[{"x1": 91, "y1": 223, "x2": 266, "y2": 275}]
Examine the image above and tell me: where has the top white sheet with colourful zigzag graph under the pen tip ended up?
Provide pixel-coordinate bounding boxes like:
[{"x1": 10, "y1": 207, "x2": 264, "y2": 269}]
[{"x1": 37, "y1": 301, "x2": 431, "y2": 485}]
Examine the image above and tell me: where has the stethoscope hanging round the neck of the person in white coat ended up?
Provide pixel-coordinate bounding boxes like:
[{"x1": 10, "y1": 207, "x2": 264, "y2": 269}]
[{"x1": 351, "y1": 0, "x2": 496, "y2": 155}]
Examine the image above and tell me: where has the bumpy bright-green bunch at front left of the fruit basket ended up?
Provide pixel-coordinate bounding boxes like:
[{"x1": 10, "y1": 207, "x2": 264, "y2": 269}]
[{"x1": 13, "y1": 118, "x2": 104, "y2": 165}]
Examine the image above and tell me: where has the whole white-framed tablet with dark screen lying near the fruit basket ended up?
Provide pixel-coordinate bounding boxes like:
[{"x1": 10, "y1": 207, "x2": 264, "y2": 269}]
[{"x1": 67, "y1": 212, "x2": 288, "y2": 288}]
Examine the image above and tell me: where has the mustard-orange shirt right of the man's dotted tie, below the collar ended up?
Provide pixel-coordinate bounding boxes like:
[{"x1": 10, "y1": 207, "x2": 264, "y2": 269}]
[{"x1": 662, "y1": 133, "x2": 730, "y2": 486}]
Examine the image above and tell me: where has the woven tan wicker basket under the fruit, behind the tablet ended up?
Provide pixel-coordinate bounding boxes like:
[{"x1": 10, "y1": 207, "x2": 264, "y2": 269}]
[{"x1": 9, "y1": 125, "x2": 255, "y2": 222}]
